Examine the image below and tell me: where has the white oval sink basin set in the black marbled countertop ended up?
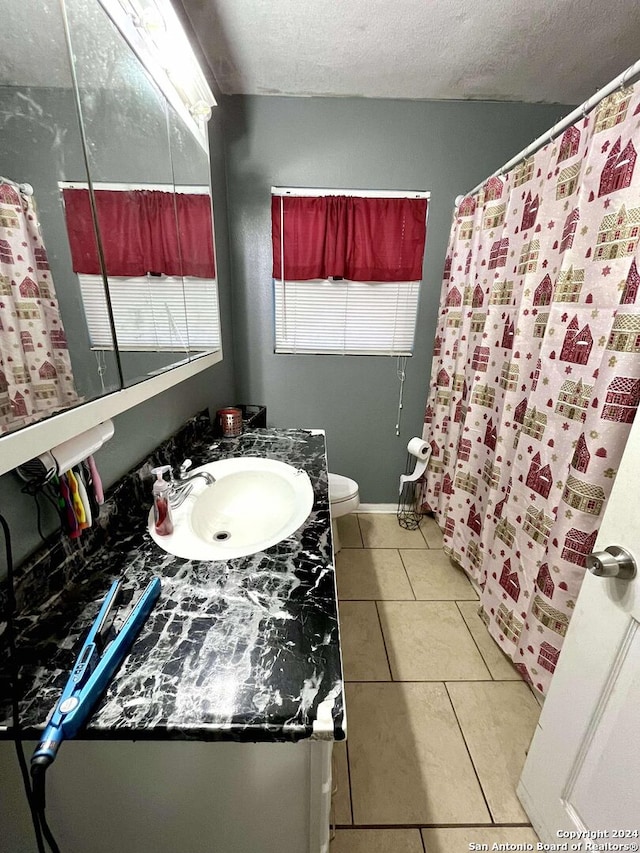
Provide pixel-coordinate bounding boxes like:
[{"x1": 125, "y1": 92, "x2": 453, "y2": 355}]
[{"x1": 149, "y1": 456, "x2": 313, "y2": 560}]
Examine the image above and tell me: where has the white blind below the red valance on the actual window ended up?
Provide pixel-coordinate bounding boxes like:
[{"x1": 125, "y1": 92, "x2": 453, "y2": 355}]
[{"x1": 274, "y1": 279, "x2": 420, "y2": 355}]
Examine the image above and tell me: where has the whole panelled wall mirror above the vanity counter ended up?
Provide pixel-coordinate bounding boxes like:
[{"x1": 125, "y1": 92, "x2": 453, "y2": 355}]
[{"x1": 0, "y1": 0, "x2": 221, "y2": 442}]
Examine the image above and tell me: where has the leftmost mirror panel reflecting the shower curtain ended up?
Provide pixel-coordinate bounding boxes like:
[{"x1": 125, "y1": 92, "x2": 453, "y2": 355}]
[{"x1": 0, "y1": 0, "x2": 120, "y2": 433}]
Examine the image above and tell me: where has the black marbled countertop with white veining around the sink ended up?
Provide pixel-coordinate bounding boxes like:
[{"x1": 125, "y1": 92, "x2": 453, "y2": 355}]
[{"x1": 0, "y1": 421, "x2": 345, "y2": 741}]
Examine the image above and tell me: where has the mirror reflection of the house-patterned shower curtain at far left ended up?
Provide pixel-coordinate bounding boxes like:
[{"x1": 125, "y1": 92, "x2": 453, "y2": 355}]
[{"x1": 0, "y1": 181, "x2": 78, "y2": 433}]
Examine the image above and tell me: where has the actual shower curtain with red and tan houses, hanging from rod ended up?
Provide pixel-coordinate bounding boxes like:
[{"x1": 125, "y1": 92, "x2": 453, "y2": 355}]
[{"x1": 422, "y1": 87, "x2": 640, "y2": 693}]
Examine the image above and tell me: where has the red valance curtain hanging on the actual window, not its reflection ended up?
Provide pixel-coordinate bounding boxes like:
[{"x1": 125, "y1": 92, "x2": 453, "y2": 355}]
[{"x1": 271, "y1": 195, "x2": 427, "y2": 281}]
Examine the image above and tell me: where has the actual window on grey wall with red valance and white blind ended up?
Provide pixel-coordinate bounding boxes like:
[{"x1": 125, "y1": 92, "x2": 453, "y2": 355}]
[{"x1": 272, "y1": 187, "x2": 429, "y2": 356}]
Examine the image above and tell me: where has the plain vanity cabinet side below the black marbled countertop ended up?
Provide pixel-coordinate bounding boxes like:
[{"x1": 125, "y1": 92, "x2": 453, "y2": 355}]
[{"x1": 0, "y1": 740, "x2": 333, "y2": 853}]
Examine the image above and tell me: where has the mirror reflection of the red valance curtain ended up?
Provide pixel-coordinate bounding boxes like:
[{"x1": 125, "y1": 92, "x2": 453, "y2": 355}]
[{"x1": 63, "y1": 189, "x2": 215, "y2": 278}]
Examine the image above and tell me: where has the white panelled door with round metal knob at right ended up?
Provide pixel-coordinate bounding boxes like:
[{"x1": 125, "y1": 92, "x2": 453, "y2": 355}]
[{"x1": 518, "y1": 416, "x2": 640, "y2": 850}]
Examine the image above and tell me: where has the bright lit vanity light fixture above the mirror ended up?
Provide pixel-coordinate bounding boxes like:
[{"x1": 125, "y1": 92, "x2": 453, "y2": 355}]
[{"x1": 99, "y1": 0, "x2": 216, "y2": 151}]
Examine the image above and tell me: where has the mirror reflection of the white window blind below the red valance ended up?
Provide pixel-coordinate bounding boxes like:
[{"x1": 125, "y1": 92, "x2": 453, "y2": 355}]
[{"x1": 78, "y1": 274, "x2": 221, "y2": 352}]
